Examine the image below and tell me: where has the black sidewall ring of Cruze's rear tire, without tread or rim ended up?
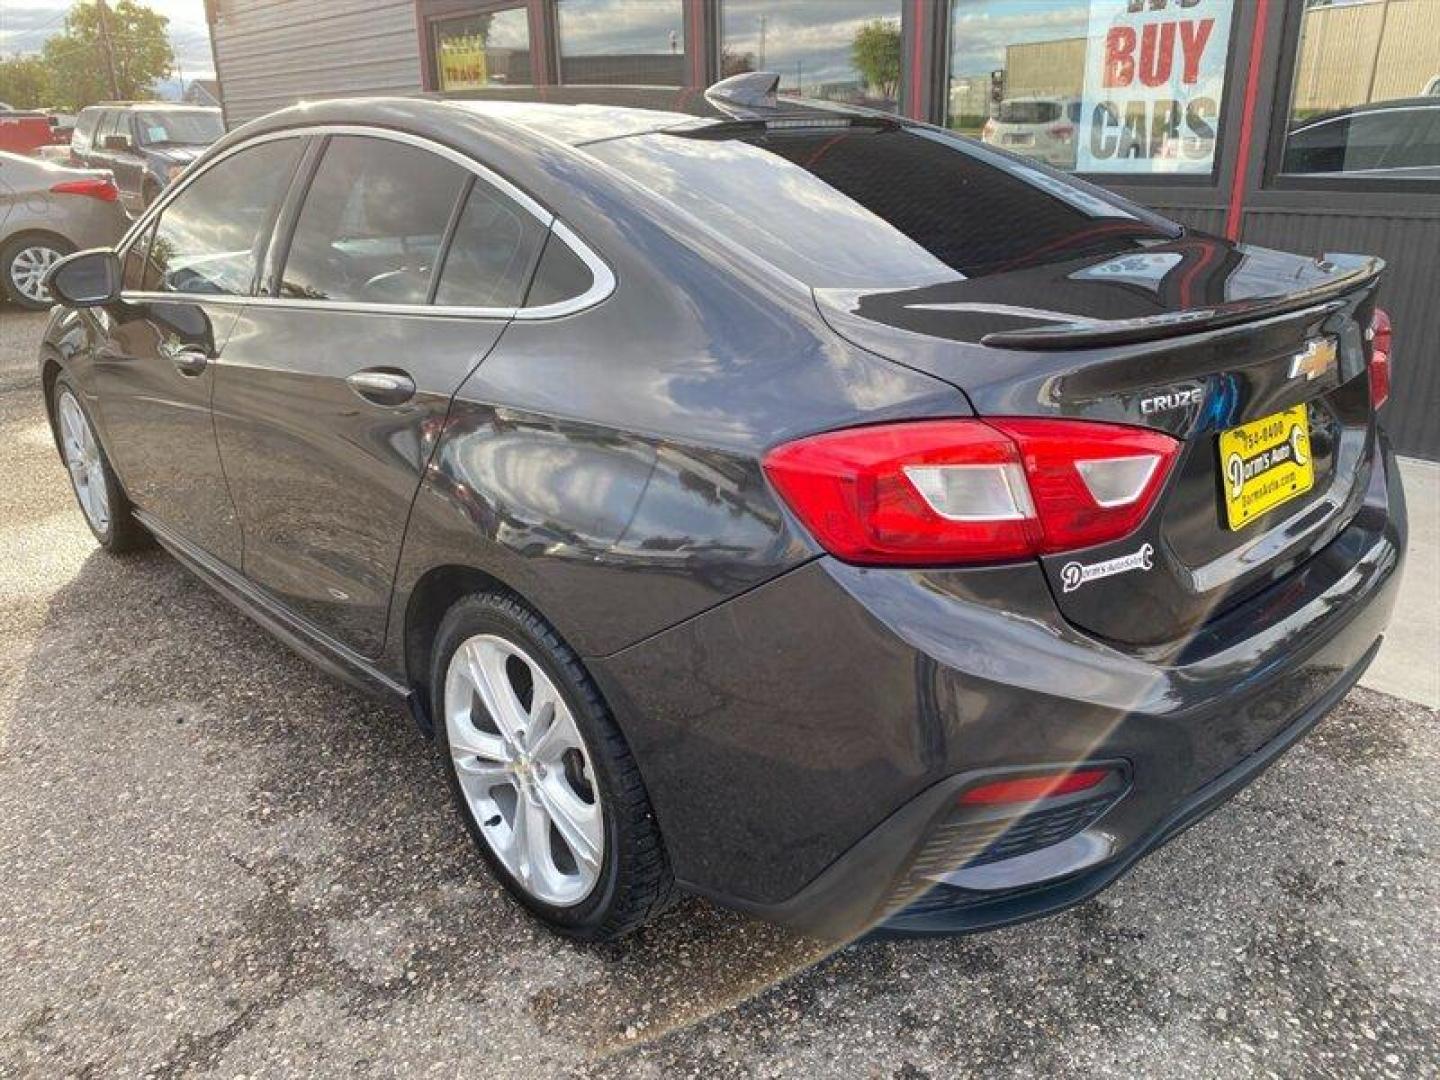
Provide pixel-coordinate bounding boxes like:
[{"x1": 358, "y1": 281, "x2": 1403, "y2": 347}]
[{"x1": 431, "y1": 593, "x2": 625, "y2": 936}]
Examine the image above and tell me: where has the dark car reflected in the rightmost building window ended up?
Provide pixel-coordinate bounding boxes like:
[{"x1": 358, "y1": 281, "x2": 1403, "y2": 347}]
[{"x1": 1284, "y1": 96, "x2": 1440, "y2": 180}]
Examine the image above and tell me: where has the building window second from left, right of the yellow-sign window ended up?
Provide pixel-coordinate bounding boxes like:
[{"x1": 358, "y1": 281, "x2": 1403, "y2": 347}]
[{"x1": 554, "y1": 0, "x2": 685, "y2": 86}]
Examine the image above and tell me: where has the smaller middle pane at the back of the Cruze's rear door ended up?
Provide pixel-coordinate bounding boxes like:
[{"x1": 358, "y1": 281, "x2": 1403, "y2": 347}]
[{"x1": 435, "y1": 179, "x2": 546, "y2": 308}]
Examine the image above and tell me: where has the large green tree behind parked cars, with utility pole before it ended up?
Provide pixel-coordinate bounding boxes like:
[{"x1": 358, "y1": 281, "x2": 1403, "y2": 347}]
[{"x1": 40, "y1": 0, "x2": 176, "y2": 111}]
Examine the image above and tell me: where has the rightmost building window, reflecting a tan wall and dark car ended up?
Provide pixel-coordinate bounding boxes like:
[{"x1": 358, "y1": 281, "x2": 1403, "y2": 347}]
[{"x1": 1280, "y1": 0, "x2": 1440, "y2": 181}]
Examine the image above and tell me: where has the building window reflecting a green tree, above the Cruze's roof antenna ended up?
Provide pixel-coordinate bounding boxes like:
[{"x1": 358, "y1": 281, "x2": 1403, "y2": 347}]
[{"x1": 720, "y1": 0, "x2": 900, "y2": 112}]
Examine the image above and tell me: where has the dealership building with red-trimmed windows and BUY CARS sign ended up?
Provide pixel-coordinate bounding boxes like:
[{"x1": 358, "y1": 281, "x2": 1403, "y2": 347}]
[{"x1": 206, "y1": 0, "x2": 1440, "y2": 459}]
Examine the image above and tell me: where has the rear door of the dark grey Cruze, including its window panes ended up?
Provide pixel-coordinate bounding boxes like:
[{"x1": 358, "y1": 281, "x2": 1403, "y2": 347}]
[{"x1": 215, "y1": 130, "x2": 549, "y2": 657}]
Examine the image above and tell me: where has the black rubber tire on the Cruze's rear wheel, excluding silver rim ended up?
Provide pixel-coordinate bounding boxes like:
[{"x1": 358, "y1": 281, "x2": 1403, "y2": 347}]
[{"x1": 431, "y1": 592, "x2": 675, "y2": 942}]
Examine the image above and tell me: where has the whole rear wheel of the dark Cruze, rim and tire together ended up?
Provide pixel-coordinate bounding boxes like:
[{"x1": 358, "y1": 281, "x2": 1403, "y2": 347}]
[{"x1": 431, "y1": 593, "x2": 674, "y2": 940}]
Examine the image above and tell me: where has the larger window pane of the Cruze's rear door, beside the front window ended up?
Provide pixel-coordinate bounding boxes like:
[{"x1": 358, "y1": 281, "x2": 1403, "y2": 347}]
[{"x1": 281, "y1": 135, "x2": 469, "y2": 304}]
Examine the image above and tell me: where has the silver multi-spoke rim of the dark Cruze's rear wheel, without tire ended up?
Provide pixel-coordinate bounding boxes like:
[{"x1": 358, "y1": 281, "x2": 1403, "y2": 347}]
[{"x1": 445, "y1": 634, "x2": 605, "y2": 907}]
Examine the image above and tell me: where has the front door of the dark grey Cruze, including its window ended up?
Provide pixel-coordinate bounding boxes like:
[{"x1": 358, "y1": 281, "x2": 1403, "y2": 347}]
[{"x1": 94, "y1": 138, "x2": 301, "y2": 569}]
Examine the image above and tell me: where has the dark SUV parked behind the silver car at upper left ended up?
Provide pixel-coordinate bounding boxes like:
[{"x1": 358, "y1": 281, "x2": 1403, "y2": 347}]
[{"x1": 71, "y1": 101, "x2": 225, "y2": 210}]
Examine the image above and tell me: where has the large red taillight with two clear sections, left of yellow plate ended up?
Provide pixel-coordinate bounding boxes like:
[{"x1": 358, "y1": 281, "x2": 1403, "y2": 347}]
[{"x1": 765, "y1": 418, "x2": 1179, "y2": 566}]
